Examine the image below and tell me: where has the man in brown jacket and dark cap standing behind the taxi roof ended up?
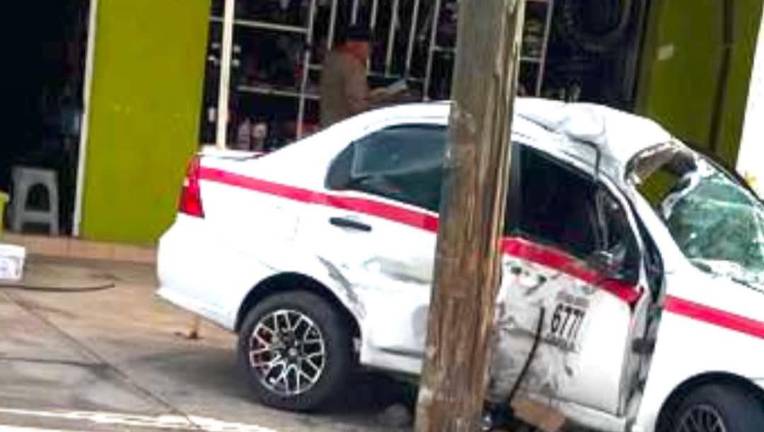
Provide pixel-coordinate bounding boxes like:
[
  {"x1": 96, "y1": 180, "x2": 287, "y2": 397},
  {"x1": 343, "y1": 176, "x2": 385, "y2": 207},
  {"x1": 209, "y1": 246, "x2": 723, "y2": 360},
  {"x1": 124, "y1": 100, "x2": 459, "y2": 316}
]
[{"x1": 321, "y1": 26, "x2": 387, "y2": 127}]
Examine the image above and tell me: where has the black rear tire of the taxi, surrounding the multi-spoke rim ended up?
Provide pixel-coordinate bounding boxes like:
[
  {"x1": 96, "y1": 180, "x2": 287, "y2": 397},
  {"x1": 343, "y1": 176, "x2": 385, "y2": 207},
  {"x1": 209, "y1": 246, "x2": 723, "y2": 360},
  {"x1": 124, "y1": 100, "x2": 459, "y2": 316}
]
[{"x1": 238, "y1": 291, "x2": 354, "y2": 411}]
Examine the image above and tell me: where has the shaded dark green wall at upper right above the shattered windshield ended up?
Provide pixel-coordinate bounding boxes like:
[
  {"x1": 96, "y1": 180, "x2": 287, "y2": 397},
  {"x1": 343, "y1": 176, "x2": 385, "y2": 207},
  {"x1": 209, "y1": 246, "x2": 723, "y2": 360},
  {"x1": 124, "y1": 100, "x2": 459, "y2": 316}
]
[{"x1": 637, "y1": 0, "x2": 762, "y2": 164}]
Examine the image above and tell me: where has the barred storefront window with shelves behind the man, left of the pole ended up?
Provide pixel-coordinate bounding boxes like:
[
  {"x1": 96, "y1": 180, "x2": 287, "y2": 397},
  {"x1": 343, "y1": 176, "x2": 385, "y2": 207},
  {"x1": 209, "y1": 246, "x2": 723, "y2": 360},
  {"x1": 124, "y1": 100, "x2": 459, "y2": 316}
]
[{"x1": 200, "y1": 0, "x2": 490, "y2": 151}]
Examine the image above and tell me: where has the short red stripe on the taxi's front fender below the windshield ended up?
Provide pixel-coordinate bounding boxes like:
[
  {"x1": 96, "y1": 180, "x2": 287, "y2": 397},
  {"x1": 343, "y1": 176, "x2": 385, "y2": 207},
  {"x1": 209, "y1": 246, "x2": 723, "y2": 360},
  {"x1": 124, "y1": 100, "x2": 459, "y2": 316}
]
[{"x1": 664, "y1": 296, "x2": 764, "y2": 339}]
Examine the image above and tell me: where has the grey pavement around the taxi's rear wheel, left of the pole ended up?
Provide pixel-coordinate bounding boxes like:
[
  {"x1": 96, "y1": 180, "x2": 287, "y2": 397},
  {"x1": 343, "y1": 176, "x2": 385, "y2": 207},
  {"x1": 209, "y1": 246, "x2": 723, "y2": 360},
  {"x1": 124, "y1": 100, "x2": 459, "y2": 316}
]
[{"x1": 0, "y1": 259, "x2": 408, "y2": 432}]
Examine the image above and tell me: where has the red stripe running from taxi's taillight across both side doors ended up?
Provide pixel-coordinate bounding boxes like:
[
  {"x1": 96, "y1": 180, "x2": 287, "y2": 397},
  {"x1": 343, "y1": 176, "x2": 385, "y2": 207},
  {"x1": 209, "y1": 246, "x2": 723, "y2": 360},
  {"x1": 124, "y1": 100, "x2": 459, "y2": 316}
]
[{"x1": 200, "y1": 168, "x2": 641, "y2": 305}]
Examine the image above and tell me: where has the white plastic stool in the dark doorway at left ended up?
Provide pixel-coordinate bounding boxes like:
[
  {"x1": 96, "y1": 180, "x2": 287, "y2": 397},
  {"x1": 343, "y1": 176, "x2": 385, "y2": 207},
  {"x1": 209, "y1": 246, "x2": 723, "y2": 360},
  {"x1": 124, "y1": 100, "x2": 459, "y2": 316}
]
[{"x1": 11, "y1": 166, "x2": 58, "y2": 236}]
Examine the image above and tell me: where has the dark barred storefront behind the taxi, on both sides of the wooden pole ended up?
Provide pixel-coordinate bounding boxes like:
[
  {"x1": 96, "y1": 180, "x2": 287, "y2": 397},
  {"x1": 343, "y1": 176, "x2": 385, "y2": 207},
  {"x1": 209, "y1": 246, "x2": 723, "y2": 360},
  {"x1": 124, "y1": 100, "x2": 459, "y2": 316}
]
[{"x1": 200, "y1": 0, "x2": 642, "y2": 151}]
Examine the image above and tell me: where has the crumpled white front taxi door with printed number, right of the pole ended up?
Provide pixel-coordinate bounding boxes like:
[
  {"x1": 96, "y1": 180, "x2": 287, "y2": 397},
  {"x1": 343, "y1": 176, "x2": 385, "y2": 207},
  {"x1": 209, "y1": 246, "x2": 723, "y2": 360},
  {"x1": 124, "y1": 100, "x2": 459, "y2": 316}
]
[{"x1": 491, "y1": 145, "x2": 650, "y2": 414}]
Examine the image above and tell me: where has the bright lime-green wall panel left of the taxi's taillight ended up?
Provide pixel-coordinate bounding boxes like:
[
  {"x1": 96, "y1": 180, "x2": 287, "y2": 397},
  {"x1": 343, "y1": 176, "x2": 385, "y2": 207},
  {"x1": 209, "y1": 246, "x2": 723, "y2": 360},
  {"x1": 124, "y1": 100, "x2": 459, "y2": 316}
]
[{"x1": 81, "y1": 0, "x2": 210, "y2": 244}]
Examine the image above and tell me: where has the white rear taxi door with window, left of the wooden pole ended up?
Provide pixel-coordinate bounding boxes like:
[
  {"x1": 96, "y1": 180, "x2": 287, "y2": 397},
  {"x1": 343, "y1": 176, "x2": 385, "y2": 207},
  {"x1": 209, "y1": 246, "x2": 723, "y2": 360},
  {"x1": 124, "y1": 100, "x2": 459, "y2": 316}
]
[{"x1": 305, "y1": 120, "x2": 446, "y2": 373}]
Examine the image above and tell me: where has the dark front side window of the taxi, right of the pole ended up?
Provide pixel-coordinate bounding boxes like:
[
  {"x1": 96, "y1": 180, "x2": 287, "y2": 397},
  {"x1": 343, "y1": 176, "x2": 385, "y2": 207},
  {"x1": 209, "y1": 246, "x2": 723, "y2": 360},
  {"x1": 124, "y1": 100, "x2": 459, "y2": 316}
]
[{"x1": 507, "y1": 145, "x2": 640, "y2": 282}]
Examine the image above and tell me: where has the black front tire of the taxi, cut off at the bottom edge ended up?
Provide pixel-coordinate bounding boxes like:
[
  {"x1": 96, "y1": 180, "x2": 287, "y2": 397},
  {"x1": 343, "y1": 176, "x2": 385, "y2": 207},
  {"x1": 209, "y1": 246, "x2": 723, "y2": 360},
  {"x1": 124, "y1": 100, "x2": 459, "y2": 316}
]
[{"x1": 660, "y1": 384, "x2": 764, "y2": 432}]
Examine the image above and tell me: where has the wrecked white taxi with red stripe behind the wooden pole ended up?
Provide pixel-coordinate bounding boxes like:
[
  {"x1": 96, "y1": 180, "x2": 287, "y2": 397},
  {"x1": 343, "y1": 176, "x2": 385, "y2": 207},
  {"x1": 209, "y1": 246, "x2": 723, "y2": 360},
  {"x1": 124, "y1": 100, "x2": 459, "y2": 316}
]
[{"x1": 158, "y1": 99, "x2": 764, "y2": 432}]
